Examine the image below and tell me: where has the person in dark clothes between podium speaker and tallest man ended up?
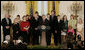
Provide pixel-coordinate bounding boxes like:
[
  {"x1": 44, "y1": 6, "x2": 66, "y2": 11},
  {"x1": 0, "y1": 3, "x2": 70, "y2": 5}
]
[{"x1": 45, "y1": 14, "x2": 51, "y2": 46}]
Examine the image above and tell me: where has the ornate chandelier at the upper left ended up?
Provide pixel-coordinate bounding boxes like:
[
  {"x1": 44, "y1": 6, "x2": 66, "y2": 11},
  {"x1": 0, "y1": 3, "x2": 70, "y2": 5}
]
[{"x1": 3, "y1": 1, "x2": 15, "y2": 14}]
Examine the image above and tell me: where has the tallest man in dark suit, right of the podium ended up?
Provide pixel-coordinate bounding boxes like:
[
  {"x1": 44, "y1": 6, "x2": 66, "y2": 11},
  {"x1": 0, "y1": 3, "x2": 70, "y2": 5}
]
[{"x1": 49, "y1": 10, "x2": 57, "y2": 45}]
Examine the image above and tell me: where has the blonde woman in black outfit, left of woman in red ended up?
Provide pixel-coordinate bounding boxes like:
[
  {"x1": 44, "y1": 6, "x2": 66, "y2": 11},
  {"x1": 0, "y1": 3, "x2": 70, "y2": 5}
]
[{"x1": 12, "y1": 18, "x2": 20, "y2": 45}]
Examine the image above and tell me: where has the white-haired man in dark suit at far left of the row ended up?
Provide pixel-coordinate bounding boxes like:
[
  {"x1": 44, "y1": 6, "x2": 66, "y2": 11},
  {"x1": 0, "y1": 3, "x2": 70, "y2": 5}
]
[{"x1": 2, "y1": 14, "x2": 12, "y2": 40}]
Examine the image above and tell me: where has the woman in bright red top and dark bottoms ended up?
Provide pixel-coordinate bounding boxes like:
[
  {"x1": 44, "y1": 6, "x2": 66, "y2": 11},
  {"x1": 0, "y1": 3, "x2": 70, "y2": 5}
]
[{"x1": 20, "y1": 16, "x2": 30, "y2": 44}]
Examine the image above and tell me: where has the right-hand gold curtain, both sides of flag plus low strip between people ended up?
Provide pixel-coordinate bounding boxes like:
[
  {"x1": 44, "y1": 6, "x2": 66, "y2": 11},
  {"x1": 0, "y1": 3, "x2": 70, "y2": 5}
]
[{"x1": 48, "y1": 1, "x2": 59, "y2": 44}]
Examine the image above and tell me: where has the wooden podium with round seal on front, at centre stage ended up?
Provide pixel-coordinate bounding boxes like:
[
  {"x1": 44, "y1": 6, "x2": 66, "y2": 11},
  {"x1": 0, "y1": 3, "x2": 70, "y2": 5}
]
[{"x1": 38, "y1": 25, "x2": 50, "y2": 46}]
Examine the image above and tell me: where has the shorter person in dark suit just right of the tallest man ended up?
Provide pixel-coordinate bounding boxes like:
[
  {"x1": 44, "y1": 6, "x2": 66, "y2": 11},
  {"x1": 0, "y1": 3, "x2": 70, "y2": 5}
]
[{"x1": 54, "y1": 15, "x2": 63, "y2": 45}]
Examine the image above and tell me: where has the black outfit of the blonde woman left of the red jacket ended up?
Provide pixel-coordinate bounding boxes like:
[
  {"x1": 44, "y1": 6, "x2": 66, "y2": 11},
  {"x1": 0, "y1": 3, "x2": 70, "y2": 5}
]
[{"x1": 13, "y1": 23, "x2": 20, "y2": 40}]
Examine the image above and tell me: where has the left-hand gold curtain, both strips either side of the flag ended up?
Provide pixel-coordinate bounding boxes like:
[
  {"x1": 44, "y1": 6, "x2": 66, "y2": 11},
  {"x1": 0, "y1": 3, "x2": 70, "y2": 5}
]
[{"x1": 25, "y1": 1, "x2": 37, "y2": 15}]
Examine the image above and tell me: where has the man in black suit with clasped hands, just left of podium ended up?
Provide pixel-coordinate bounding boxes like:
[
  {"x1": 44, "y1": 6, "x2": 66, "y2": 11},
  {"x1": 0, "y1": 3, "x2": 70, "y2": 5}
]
[{"x1": 31, "y1": 12, "x2": 42, "y2": 45}]
